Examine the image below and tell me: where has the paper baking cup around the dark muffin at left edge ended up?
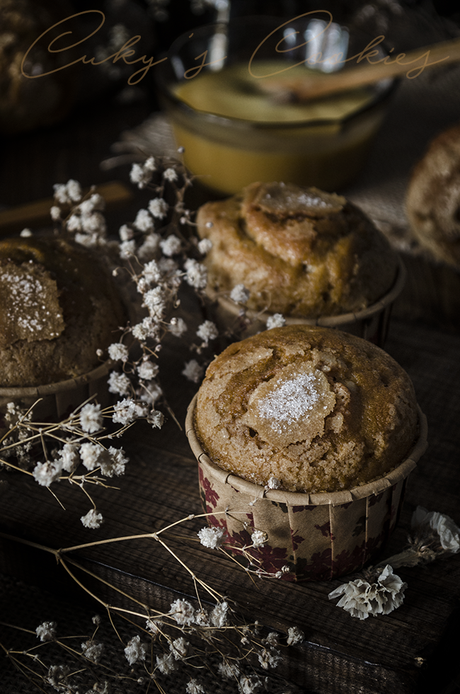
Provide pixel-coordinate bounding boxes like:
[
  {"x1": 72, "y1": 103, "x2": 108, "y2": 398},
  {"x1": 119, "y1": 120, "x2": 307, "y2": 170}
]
[{"x1": 0, "y1": 360, "x2": 113, "y2": 434}]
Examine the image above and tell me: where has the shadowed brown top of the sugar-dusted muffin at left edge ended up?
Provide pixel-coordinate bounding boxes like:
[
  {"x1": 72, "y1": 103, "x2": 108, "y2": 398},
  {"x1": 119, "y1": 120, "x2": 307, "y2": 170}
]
[{"x1": 0, "y1": 237, "x2": 124, "y2": 388}]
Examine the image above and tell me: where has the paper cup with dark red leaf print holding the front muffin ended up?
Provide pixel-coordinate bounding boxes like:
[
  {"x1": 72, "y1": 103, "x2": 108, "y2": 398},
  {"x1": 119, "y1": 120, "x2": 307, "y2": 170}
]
[{"x1": 186, "y1": 396, "x2": 427, "y2": 581}]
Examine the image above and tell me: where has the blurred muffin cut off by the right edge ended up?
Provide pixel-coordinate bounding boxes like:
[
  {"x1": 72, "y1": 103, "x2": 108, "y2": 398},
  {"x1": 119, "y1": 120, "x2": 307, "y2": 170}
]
[{"x1": 406, "y1": 124, "x2": 460, "y2": 268}]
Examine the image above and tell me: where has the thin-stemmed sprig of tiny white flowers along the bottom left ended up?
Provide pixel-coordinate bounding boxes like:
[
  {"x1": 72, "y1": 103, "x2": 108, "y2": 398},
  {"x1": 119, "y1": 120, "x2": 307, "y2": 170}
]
[{"x1": 0, "y1": 514, "x2": 304, "y2": 694}]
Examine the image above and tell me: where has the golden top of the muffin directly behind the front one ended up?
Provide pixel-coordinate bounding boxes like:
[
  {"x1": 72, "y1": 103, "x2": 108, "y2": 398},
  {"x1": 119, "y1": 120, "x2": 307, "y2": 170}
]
[{"x1": 197, "y1": 183, "x2": 398, "y2": 318}]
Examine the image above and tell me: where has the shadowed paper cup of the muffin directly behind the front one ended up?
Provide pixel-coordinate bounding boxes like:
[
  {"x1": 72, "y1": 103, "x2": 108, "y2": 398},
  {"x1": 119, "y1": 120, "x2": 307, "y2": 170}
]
[{"x1": 207, "y1": 258, "x2": 406, "y2": 347}]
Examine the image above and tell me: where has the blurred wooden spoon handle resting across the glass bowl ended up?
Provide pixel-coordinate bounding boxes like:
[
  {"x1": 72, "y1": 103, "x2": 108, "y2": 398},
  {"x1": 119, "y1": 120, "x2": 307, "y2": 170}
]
[{"x1": 260, "y1": 38, "x2": 460, "y2": 101}]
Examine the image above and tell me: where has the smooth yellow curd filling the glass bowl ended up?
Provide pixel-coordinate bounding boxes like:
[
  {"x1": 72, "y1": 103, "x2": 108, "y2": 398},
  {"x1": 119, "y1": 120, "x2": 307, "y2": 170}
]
[{"x1": 171, "y1": 61, "x2": 384, "y2": 194}]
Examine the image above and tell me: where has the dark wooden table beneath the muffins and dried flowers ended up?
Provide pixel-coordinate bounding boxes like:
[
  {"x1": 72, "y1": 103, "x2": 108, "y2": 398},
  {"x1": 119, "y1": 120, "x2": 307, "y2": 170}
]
[{"x1": 0, "y1": 39, "x2": 460, "y2": 694}]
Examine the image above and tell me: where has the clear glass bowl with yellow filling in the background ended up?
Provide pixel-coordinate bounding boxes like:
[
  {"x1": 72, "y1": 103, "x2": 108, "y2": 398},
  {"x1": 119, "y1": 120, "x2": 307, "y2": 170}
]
[{"x1": 156, "y1": 11, "x2": 396, "y2": 195}]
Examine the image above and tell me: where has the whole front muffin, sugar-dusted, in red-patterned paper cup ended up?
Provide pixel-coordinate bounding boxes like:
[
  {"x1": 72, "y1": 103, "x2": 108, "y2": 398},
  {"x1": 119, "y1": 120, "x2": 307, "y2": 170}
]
[{"x1": 187, "y1": 325, "x2": 426, "y2": 580}]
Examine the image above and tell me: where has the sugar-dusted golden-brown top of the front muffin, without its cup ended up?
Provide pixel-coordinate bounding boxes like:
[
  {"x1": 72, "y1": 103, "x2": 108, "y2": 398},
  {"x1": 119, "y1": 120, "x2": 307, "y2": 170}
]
[{"x1": 195, "y1": 325, "x2": 418, "y2": 493}]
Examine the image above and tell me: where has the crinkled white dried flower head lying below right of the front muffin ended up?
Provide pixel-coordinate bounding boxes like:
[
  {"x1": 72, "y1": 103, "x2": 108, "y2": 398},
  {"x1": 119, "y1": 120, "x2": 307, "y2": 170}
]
[{"x1": 329, "y1": 564, "x2": 407, "y2": 619}]
